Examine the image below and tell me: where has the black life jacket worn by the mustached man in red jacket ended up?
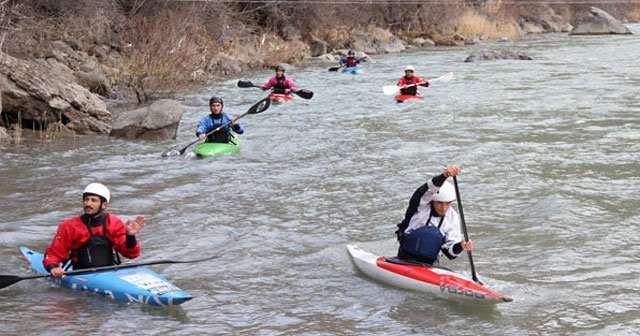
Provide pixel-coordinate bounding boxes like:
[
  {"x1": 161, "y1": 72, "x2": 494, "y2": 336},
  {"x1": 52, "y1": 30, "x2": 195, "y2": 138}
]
[{"x1": 73, "y1": 213, "x2": 119, "y2": 269}]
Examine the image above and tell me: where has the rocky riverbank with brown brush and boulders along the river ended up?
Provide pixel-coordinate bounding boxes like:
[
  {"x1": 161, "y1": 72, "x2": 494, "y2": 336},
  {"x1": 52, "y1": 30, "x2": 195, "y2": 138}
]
[{"x1": 0, "y1": 1, "x2": 628, "y2": 139}]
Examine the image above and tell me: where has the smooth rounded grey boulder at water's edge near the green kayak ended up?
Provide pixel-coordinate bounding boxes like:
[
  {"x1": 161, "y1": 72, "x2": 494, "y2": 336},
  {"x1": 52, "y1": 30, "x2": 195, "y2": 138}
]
[{"x1": 110, "y1": 99, "x2": 184, "y2": 140}]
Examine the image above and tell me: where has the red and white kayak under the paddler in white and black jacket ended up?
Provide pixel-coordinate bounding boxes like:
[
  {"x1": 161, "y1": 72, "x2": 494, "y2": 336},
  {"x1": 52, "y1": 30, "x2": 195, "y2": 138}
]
[{"x1": 347, "y1": 245, "x2": 513, "y2": 303}]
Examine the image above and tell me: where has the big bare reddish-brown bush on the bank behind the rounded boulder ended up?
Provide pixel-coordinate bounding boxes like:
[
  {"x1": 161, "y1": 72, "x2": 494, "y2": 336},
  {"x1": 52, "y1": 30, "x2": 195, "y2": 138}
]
[{"x1": 114, "y1": 8, "x2": 218, "y2": 102}]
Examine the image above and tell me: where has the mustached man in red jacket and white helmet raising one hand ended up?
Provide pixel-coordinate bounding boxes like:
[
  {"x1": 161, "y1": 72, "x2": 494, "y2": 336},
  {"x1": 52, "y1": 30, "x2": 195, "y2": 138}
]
[{"x1": 42, "y1": 183, "x2": 144, "y2": 278}]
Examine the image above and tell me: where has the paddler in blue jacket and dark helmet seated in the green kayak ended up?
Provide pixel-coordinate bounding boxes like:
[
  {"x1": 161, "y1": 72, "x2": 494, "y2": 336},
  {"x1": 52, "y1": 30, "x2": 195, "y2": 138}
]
[{"x1": 196, "y1": 97, "x2": 244, "y2": 143}]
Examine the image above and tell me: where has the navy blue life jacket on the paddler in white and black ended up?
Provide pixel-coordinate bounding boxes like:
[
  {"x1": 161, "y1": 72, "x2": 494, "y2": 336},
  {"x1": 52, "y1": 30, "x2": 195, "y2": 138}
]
[{"x1": 398, "y1": 214, "x2": 445, "y2": 264}]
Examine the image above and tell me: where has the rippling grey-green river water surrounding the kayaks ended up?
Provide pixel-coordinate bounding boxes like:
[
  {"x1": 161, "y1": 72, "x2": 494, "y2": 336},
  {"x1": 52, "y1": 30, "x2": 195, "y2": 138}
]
[{"x1": 0, "y1": 26, "x2": 640, "y2": 335}]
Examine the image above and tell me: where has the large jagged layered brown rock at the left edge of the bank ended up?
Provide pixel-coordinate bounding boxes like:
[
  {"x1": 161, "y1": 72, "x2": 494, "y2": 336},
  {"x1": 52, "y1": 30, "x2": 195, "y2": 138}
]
[{"x1": 0, "y1": 52, "x2": 111, "y2": 134}]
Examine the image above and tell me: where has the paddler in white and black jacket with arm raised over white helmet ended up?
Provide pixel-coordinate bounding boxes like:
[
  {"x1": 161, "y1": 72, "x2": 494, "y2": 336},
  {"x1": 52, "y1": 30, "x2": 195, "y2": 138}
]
[{"x1": 396, "y1": 165, "x2": 473, "y2": 265}]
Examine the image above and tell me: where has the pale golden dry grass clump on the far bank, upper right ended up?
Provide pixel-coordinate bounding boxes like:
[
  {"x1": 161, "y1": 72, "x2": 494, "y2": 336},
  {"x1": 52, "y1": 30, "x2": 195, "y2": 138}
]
[{"x1": 455, "y1": 10, "x2": 521, "y2": 39}]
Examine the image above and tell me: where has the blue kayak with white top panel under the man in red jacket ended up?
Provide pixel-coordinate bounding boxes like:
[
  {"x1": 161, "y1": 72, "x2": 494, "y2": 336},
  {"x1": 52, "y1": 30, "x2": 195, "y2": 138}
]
[{"x1": 20, "y1": 247, "x2": 191, "y2": 306}]
